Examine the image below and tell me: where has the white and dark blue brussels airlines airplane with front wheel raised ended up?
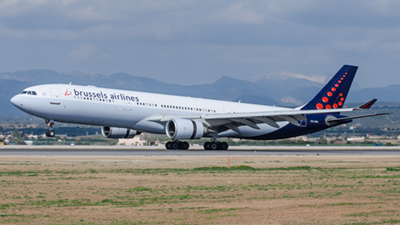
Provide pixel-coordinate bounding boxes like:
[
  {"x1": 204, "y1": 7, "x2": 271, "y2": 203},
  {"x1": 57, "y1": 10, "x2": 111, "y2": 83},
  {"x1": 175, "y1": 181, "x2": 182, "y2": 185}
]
[{"x1": 10, "y1": 65, "x2": 387, "y2": 150}]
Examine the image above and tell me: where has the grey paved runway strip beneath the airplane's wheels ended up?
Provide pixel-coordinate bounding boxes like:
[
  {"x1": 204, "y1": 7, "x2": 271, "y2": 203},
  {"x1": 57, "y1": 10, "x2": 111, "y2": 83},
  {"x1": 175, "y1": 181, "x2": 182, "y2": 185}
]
[{"x1": 0, "y1": 146, "x2": 400, "y2": 156}]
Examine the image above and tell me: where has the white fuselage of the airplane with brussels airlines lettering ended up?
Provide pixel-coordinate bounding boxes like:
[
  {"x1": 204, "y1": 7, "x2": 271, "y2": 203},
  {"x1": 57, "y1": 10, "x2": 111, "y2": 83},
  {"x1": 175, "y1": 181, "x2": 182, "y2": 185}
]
[{"x1": 11, "y1": 84, "x2": 291, "y2": 137}]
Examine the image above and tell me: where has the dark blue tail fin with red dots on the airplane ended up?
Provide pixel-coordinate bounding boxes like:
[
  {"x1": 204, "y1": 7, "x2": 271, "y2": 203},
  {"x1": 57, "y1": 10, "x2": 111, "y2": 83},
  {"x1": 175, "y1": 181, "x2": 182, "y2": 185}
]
[{"x1": 301, "y1": 65, "x2": 358, "y2": 110}]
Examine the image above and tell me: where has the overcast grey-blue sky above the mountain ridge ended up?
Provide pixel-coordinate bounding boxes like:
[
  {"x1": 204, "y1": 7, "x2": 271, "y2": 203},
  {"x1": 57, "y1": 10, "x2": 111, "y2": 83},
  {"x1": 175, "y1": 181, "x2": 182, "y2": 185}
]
[{"x1": 0, "y1": 0, "x2": 400, "y2": 87}]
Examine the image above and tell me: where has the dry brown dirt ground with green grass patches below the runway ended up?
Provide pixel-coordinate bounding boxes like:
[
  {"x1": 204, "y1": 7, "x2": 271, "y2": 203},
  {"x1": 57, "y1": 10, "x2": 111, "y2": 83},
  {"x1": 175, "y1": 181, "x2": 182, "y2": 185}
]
[{"x1": 0, "y1": 155, "x2": 400, "y2": 224}]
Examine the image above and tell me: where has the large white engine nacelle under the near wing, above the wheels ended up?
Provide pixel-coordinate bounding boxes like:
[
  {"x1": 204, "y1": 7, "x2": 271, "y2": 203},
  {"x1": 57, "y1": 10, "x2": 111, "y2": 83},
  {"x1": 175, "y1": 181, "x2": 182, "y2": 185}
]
[{"x1": 165, "y1": 119, "x2": 205, "y2": 140}]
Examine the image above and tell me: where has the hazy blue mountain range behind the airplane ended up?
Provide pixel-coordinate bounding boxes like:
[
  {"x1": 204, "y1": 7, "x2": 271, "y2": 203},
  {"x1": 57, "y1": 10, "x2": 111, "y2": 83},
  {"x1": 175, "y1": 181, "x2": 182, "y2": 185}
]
[{"x1": 0, "y1": 70, "x2": 400, "y2": 116}]
